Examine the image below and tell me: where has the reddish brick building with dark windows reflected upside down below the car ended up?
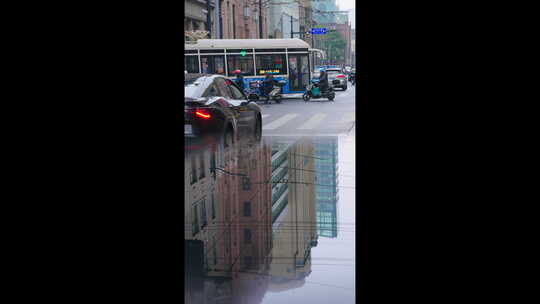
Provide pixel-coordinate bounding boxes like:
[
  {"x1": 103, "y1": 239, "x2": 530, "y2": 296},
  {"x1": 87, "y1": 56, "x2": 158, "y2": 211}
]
[{"x1": 184, "y1": 137, "x2": 272, "y2": 279}]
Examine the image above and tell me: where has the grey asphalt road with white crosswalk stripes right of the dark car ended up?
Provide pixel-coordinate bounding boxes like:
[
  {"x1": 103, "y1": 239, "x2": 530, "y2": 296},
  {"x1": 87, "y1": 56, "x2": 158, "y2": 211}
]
[{"x1": 261, "y1": 83, "x2": 355, "y2": 136}]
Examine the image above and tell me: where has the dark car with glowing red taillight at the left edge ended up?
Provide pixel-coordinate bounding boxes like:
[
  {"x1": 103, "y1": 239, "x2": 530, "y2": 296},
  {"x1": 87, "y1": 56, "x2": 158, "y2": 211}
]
[{"x1": 184, "y1": 74, "x2": 262, "y2": 146}]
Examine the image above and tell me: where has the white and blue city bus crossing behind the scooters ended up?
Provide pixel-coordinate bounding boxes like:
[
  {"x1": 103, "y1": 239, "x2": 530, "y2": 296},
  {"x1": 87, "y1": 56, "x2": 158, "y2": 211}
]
[{"x1": 184, "y1": 38, "x2": 324, "y2": 97}]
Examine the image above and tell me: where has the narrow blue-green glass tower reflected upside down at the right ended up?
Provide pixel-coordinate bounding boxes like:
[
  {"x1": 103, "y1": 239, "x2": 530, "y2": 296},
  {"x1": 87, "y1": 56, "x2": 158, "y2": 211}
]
[{"x1": 314, "y1": 137, "x2": 339, "y2": 238}]
